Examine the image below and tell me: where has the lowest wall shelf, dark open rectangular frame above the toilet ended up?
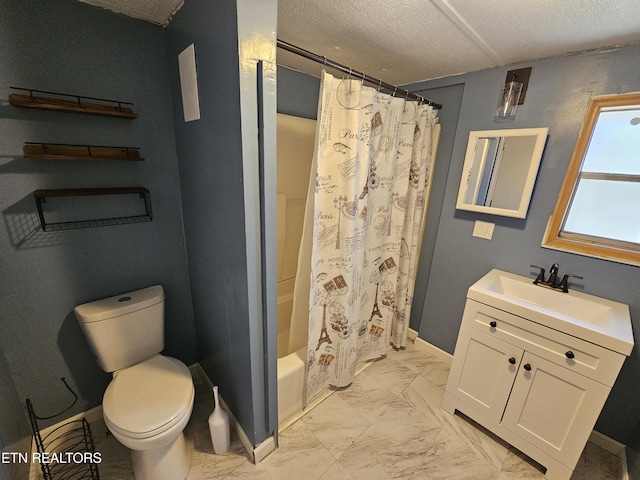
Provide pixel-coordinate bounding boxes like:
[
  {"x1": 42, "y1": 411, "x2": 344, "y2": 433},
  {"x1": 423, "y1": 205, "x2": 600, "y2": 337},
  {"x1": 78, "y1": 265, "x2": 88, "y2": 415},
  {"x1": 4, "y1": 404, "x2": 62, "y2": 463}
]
[{"x1": 33, "y1": 187, "x2": 153, "y2": 232}]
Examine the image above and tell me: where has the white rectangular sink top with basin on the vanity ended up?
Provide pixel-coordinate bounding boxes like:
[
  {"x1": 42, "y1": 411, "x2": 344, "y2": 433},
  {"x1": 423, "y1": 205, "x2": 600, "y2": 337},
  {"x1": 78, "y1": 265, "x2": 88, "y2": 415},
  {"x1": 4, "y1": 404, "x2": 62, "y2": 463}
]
[{"x1": 467, "y1": 269, "x2": 633, "y2": 355}]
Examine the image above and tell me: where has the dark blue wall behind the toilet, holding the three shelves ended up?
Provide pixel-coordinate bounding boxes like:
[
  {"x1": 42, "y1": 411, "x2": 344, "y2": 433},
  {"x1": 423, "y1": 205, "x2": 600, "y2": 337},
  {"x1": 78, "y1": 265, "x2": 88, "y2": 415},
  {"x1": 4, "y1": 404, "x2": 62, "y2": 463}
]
[{"x1": 0, "y1": 0, "x2": 196, "y2": 441}]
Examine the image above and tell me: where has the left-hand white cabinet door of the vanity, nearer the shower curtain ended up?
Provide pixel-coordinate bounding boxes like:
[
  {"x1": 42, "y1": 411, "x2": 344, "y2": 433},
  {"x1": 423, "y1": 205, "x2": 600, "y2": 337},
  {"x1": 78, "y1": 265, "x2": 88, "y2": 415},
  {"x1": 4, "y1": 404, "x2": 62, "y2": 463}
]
[{"x1": 447, "y1": 325, "x2": 523, "y2": 422}]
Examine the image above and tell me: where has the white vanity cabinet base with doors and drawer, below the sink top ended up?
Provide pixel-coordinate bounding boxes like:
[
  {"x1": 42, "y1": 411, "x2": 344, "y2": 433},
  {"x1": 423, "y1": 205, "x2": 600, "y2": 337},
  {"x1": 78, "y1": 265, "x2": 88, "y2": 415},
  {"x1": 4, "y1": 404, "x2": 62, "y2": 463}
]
[{"x1": 443, "y1": 293, "x2": 625, "y2": 480}]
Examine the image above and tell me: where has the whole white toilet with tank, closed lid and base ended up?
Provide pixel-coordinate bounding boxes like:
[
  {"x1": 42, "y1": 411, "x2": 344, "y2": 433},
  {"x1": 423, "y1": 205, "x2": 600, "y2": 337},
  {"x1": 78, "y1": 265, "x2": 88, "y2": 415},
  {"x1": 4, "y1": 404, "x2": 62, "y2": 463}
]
[{"x1": 74, "y1": 285, "x2": 195, "y2": 480}]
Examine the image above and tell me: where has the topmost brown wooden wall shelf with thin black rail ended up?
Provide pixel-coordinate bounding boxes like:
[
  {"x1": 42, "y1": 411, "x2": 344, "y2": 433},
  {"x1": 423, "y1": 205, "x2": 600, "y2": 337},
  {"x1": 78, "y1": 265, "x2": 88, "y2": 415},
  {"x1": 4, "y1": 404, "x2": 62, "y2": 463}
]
[{"x1": 9, "y1": 87, "x2": 138, "y2": 120}]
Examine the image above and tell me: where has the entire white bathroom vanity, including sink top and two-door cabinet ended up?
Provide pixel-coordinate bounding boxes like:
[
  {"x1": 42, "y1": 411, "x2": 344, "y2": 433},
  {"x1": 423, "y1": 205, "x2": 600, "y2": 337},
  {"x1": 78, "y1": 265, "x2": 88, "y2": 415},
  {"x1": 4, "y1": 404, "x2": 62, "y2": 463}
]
[{"x1": 443, "y1": 270, "x2": 633, "y2": 480}]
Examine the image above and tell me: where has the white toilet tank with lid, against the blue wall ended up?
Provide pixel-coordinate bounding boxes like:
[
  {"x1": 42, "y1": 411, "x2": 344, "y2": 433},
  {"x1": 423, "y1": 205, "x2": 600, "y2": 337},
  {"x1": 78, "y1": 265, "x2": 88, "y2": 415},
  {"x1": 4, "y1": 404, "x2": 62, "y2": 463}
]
[{"x1": 73, "y1": 285, "x2": 164, "y2": 372}]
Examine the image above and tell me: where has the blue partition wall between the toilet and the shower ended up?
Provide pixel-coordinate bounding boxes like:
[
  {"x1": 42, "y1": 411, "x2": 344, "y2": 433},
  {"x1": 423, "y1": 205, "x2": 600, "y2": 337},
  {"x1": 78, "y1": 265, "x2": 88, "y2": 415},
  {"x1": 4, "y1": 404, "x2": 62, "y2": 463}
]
[{"x1": 167, "y1": 0, "x2": 277, "y2": 445}]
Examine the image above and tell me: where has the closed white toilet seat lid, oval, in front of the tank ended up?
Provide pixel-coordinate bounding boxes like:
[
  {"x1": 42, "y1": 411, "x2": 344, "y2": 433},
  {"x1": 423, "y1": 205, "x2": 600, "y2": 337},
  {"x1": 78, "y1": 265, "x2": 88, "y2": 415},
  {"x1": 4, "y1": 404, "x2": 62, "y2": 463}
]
[{"x1": 102, "y1": 355, "x2": 195, "y2": 439}]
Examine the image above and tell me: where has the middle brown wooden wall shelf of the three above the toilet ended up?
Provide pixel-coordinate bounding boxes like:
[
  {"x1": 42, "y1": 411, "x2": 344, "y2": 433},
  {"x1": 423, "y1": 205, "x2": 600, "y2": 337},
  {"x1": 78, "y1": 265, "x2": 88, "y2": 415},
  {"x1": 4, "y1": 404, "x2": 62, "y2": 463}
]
[{"x1": 22, "y1": 142, "x2": 144, "y2": 161}]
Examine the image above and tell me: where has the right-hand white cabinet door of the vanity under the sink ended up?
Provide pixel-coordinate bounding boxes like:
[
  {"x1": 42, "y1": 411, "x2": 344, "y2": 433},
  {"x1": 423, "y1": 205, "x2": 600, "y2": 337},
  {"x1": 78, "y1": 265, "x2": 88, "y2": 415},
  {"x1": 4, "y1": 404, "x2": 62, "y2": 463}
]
[{"x1": 502, "y1": 352, "x2": 610, "y2": 468}]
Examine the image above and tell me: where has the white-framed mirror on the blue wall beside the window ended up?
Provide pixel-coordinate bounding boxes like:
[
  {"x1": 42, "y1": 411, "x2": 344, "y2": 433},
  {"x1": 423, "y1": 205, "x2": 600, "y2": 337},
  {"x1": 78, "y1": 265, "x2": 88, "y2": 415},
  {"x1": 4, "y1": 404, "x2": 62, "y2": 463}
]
[{"x1": 456, "y1": 128, "x2": 549, "y2": 218}]
